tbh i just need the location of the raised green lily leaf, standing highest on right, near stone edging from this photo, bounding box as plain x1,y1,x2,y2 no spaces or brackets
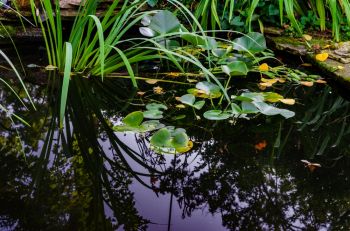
233,32,266,54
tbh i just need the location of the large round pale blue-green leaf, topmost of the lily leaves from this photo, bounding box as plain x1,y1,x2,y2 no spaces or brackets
149,10,181,35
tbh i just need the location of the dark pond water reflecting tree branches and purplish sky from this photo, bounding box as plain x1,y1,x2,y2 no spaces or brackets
0,46,350,231
